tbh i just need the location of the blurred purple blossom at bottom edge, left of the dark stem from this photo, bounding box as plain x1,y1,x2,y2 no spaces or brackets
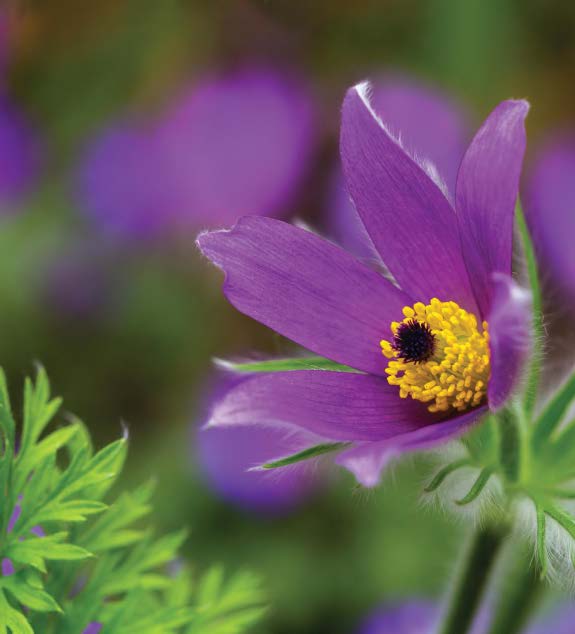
358,600,439,634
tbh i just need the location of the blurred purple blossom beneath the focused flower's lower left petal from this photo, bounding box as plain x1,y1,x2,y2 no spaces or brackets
193,377,314,514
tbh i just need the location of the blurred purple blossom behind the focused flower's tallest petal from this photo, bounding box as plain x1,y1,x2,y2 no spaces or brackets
325,76,469,259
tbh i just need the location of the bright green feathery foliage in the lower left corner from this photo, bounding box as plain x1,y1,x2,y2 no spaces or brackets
0,369,263,634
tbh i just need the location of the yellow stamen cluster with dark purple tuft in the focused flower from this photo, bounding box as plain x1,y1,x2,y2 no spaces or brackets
381,298,489,412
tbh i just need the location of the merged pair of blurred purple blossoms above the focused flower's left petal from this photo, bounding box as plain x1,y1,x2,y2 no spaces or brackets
78,68,314,239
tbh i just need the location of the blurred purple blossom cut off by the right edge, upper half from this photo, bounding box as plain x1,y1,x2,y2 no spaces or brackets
525,133,575,304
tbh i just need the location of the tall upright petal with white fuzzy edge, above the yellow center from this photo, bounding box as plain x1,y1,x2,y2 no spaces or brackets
341,84,476,311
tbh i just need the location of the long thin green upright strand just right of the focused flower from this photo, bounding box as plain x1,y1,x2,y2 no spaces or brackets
515,201,543,419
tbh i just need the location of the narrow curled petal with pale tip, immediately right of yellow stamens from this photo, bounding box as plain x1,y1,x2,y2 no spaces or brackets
487,273,532,411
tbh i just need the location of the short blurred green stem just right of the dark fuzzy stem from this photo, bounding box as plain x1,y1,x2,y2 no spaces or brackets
489,549,543,634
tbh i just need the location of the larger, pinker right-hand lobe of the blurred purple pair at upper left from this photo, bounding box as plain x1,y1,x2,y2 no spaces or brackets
160,68,315,227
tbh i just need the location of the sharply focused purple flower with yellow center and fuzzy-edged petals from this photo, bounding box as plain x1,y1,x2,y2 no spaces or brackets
198,84,530,486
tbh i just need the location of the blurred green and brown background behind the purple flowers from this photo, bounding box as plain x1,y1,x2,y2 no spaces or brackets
0,0,575,634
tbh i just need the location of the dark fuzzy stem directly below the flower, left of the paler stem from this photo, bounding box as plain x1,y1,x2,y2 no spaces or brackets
439,526,506,634
